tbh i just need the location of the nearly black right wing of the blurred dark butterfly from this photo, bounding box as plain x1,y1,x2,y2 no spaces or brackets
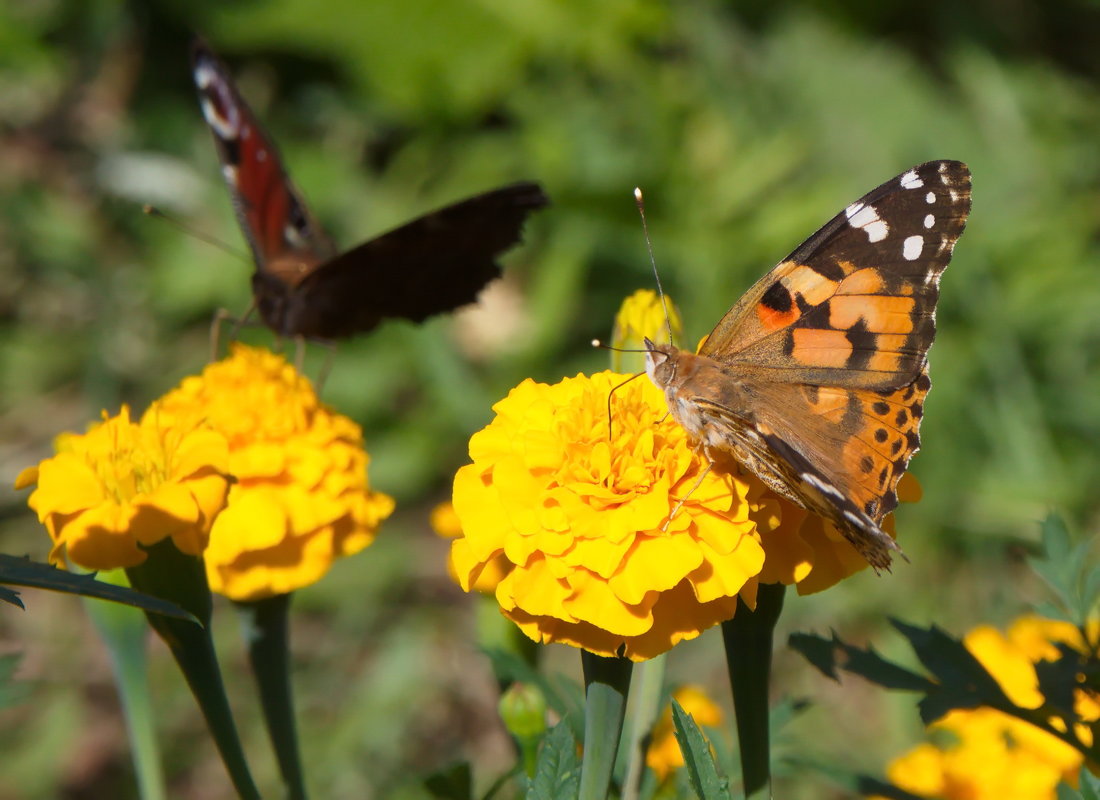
287,182,549,339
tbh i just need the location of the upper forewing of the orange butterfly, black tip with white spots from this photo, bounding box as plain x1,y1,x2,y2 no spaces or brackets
700,161,970,390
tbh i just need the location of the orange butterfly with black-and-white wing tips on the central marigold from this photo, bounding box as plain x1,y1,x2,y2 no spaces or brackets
647,161,970,569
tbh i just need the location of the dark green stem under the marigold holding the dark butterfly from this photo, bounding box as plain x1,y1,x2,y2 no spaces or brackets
237,594,306,800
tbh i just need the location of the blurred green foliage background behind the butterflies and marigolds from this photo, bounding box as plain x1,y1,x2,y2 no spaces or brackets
0,0,1100,800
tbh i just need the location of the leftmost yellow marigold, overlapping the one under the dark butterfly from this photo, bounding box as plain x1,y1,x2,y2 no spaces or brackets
15,406,229,570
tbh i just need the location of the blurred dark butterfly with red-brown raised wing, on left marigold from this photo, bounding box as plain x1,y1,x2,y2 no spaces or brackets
191,40,549,340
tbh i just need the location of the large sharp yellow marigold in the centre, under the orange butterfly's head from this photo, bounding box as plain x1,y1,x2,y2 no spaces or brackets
452,372,779,660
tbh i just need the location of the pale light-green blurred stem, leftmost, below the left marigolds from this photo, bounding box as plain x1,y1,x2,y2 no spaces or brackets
85,570,167,800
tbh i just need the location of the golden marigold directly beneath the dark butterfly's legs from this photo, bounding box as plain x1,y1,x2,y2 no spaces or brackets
145,344,394,601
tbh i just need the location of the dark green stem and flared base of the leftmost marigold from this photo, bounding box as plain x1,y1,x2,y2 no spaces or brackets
127,539,260,800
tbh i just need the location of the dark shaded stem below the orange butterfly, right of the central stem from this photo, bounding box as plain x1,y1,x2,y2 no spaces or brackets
722,583,785,798
